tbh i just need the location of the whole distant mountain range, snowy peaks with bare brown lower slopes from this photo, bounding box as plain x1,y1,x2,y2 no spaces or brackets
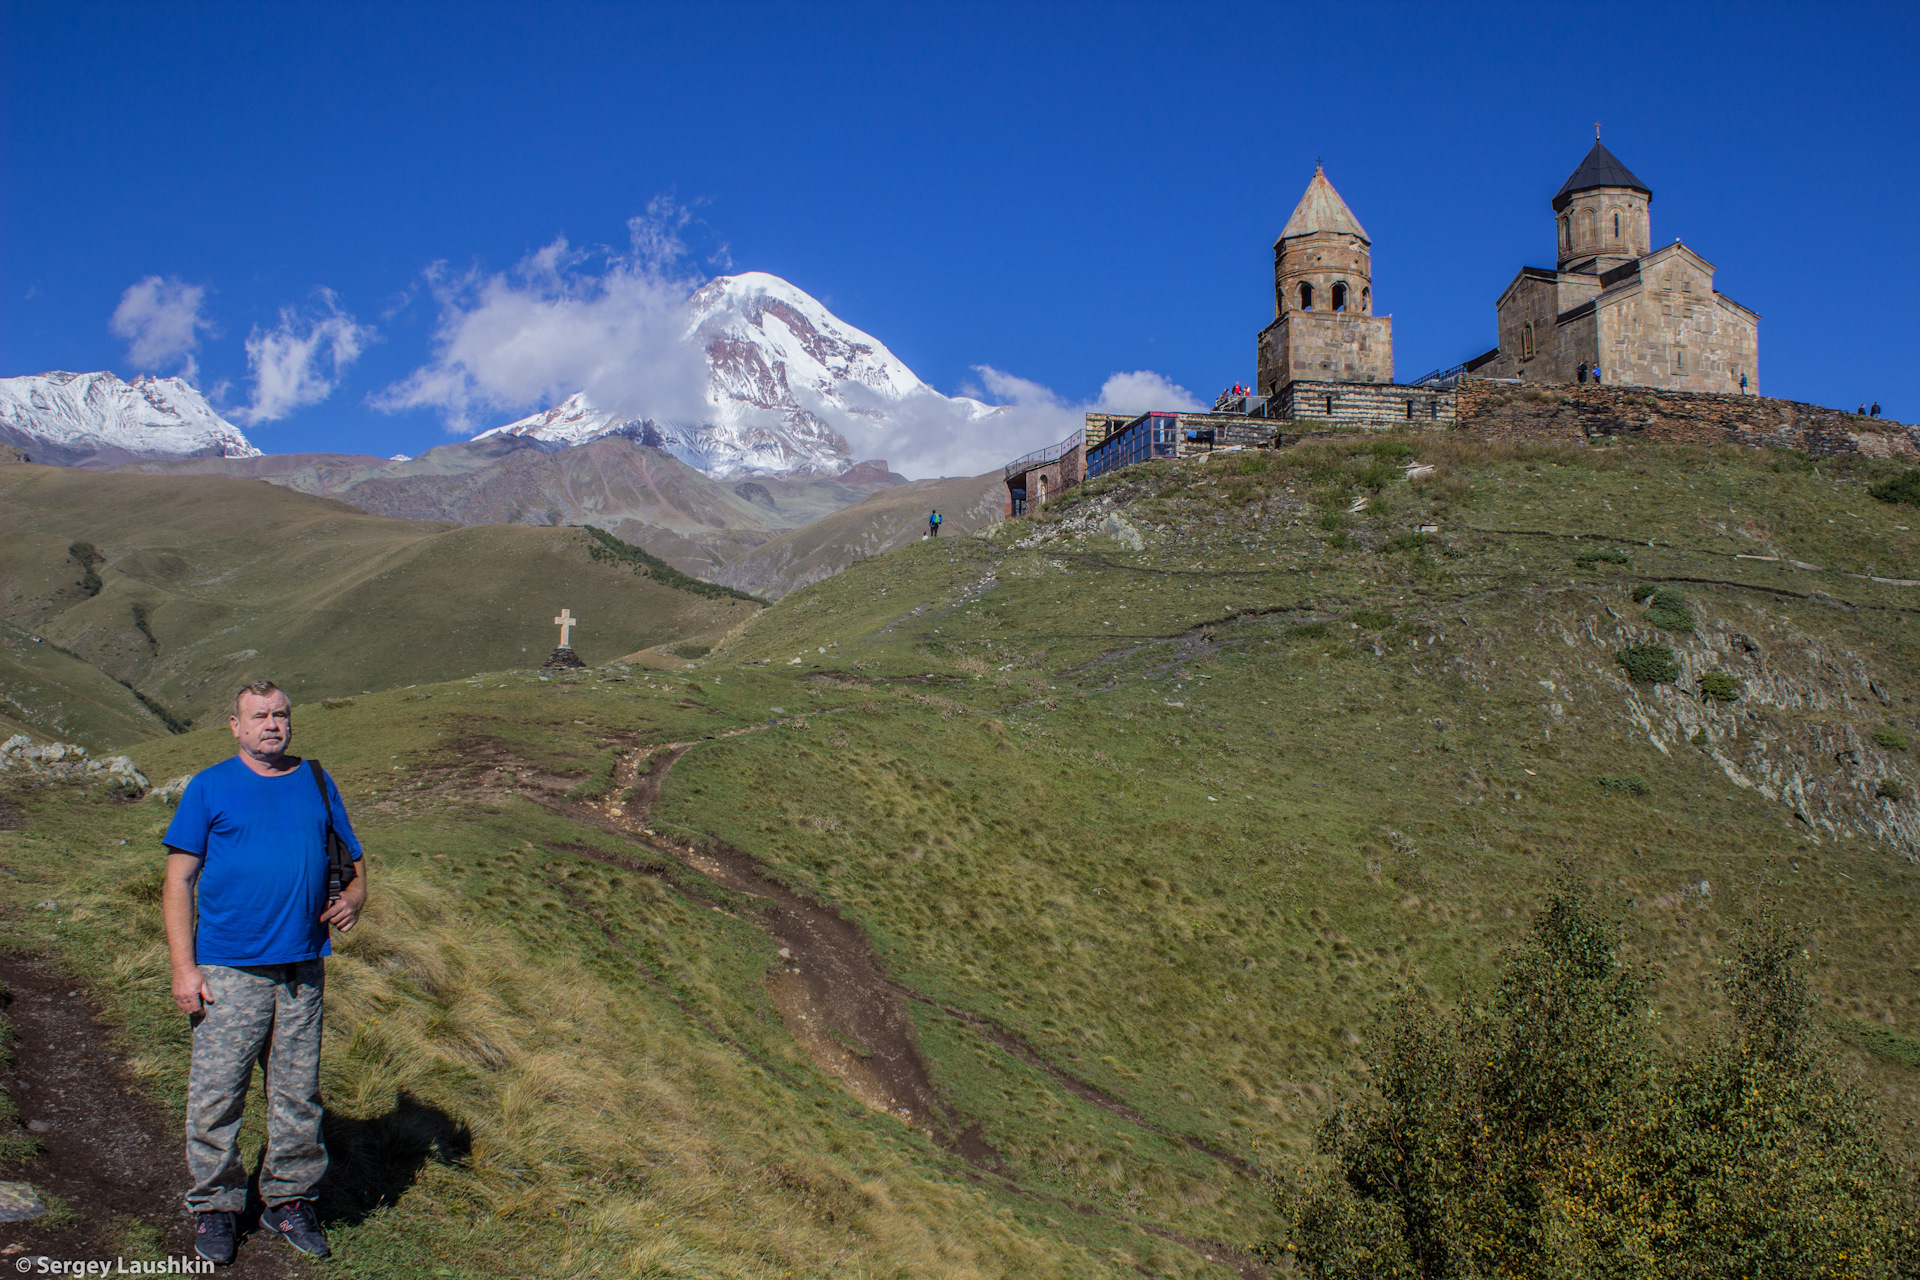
0,273,1002,595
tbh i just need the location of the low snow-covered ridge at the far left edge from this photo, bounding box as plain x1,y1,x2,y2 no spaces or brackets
0,370,259,462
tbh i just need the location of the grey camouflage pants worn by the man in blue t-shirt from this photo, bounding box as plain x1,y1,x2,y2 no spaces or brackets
186,960,326,1213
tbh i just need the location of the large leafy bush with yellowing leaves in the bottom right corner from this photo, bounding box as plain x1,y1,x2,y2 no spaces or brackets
1263,883,1920,1280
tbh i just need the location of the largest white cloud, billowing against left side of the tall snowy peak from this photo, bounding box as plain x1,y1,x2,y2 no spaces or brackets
374,198,724,434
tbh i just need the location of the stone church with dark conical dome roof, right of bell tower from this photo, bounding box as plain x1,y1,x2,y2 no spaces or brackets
1466,138,1761,395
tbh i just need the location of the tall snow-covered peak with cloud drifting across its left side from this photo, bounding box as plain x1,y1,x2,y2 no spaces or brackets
474,271,1000,478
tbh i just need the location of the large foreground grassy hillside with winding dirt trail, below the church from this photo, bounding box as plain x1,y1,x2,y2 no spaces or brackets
0,436,1920,1276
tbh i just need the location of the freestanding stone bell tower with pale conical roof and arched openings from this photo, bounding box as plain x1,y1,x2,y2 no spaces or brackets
1258,165,1394,395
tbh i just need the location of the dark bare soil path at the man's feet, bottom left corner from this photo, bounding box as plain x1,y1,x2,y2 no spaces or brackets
0,954,301,1278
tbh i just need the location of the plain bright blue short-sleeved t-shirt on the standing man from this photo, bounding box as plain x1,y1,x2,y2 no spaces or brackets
161,756,361,965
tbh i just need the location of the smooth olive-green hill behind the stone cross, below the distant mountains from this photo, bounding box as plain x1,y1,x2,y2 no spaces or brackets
0,466,755,743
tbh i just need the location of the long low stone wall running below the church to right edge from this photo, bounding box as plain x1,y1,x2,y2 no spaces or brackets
1453,378,1920,461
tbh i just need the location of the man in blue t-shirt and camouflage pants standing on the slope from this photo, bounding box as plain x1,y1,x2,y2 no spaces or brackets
161,679,367,1267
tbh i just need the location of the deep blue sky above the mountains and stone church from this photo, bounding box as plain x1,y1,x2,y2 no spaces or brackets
0,2,1920,455
